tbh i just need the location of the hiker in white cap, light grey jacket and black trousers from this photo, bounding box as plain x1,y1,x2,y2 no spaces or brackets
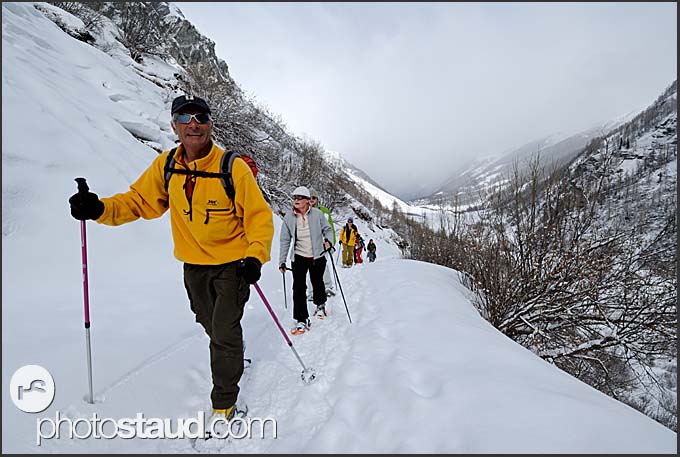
279,186,333,335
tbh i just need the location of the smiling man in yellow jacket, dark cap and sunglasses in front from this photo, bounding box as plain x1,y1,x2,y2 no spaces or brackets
69,96,274,419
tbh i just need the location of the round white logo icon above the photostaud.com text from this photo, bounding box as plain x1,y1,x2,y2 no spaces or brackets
9,365,54,413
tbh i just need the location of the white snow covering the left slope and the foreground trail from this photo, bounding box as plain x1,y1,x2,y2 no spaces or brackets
2,3,676,453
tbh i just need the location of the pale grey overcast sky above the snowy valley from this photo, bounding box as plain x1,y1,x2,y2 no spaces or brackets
176,2,677,198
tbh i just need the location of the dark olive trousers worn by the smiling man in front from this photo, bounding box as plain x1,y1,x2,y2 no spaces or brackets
184,262,250,409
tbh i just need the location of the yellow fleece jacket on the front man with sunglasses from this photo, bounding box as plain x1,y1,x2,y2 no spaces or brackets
97,143,274,265
